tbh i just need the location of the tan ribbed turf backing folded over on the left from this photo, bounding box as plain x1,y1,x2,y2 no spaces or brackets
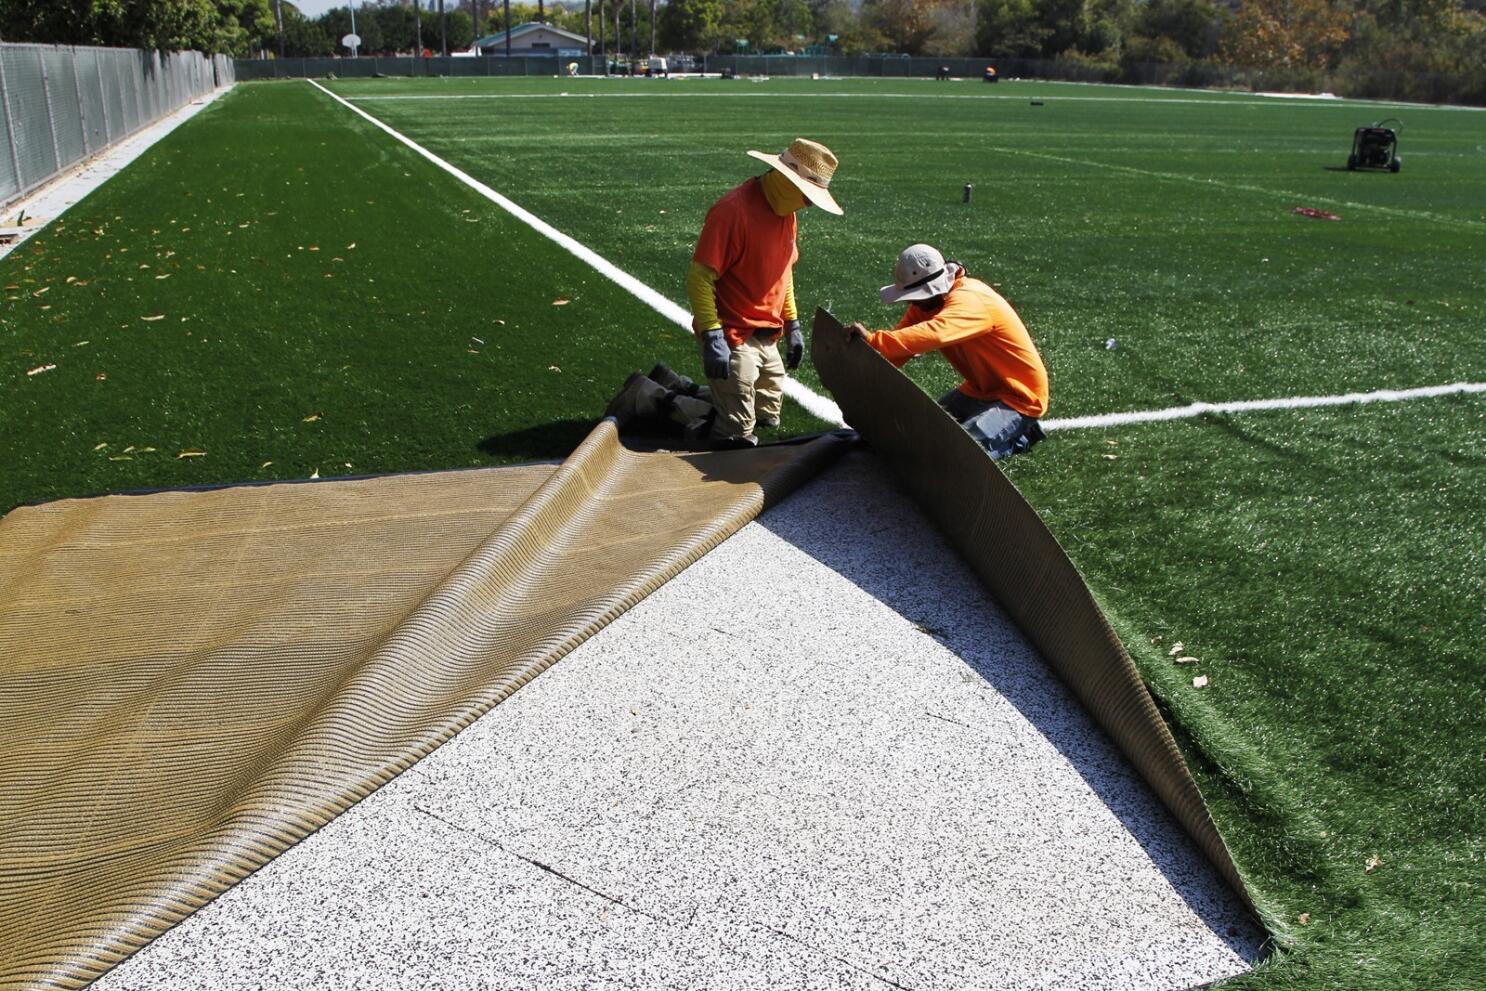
0,420,847,988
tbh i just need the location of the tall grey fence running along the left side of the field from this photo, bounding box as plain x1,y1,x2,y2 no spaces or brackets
0,45,236,212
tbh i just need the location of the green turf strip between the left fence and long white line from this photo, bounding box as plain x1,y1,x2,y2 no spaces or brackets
0,83,823,511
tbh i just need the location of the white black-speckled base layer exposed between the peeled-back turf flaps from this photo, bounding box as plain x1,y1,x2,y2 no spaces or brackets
95,455,1263,991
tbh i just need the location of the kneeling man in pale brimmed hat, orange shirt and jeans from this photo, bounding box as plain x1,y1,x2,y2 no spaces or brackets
851,244,1048,461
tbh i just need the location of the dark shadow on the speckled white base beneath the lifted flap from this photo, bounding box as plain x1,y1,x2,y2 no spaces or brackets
758,459,1266,963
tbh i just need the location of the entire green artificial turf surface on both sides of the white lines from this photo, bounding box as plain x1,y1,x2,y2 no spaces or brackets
0,79,1486,990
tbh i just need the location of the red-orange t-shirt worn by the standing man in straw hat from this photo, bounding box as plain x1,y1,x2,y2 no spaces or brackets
691,177,799,348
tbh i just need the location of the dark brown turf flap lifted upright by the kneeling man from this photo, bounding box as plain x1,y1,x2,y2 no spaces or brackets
810,311,1254,911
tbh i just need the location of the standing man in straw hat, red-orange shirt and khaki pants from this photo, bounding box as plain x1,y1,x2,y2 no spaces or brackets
687,138,841,447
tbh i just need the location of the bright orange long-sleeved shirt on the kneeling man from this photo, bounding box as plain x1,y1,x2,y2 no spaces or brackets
868,269,1048,417
